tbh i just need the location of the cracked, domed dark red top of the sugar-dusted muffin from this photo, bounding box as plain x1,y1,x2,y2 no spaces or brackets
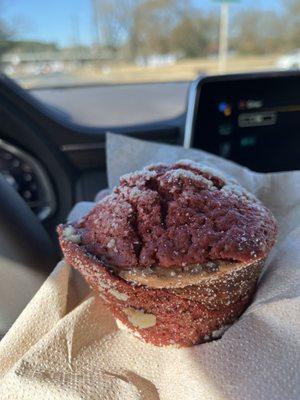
74,160,277,269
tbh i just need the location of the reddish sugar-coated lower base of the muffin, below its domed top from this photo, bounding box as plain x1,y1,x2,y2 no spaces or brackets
58,226,264,347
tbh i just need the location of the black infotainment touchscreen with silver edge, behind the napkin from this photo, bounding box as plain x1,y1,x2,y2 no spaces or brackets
185,72,300,171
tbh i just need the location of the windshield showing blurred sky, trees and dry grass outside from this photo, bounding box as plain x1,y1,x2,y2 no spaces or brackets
0,0,300,88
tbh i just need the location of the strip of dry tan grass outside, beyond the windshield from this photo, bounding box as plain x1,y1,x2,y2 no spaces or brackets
12,55,279,88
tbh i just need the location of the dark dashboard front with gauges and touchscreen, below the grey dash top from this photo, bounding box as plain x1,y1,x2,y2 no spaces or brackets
0,71,300,237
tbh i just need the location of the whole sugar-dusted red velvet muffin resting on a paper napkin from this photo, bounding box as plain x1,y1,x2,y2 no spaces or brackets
58,161,277,346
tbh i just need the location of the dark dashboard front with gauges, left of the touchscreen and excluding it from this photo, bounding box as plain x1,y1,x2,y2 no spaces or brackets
0,75,185,237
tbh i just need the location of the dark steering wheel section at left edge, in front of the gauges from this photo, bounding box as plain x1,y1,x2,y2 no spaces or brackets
0,175,59,336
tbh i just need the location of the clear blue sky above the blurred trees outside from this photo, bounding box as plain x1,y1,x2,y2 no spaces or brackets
0,0,281,46
